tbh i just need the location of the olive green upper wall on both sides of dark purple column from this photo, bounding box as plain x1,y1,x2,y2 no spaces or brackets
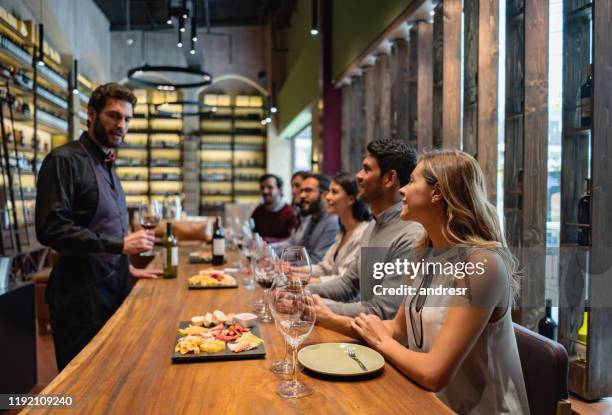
278,0,413,132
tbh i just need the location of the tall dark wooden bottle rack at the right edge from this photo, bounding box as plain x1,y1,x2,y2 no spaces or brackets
559,0,612,400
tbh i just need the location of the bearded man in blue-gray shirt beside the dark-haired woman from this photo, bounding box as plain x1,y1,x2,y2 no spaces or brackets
273,174,340,264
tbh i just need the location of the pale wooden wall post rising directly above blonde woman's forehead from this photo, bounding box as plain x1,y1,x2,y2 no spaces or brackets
442,0,463,149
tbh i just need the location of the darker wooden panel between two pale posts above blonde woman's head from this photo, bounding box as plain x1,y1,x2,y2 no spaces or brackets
463,0,480,157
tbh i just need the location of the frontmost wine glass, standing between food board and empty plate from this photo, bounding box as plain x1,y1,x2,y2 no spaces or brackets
271,278,316,399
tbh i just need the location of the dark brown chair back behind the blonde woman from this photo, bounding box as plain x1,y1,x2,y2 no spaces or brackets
514,323,572,415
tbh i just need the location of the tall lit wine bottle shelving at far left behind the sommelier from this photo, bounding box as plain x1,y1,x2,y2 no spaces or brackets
0,10,70,264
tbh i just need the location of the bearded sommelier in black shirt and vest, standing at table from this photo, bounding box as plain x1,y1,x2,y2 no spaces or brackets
36,83,156,371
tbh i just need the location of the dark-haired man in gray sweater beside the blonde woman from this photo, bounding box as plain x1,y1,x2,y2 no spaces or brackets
309,140,424,332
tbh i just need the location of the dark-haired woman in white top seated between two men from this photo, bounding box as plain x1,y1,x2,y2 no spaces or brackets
312,173,372,281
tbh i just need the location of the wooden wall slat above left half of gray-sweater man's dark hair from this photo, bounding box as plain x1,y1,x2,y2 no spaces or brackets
374,53,391,139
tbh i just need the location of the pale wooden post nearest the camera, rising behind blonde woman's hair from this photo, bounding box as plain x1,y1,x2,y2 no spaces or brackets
478,0,498,203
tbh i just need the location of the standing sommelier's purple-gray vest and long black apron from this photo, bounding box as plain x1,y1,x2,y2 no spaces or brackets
46,143,133,371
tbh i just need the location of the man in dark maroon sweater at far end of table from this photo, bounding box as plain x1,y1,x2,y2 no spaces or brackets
251,174,297,242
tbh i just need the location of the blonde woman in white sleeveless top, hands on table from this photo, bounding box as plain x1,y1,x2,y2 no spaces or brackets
351,150,529,414
